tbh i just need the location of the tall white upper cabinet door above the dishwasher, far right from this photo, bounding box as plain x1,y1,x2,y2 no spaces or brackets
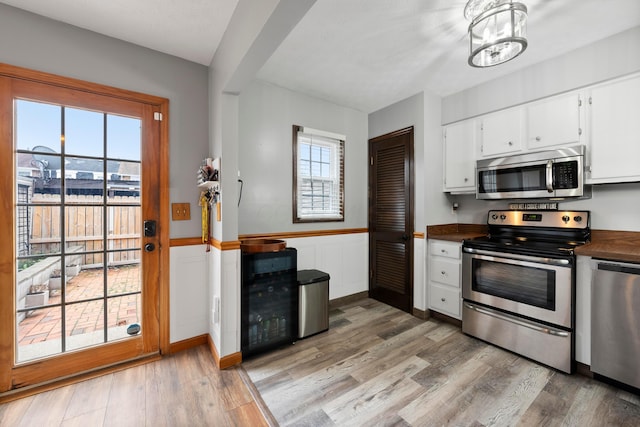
587,75,640,183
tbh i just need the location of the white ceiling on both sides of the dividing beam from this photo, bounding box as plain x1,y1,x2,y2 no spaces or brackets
0,0,640,112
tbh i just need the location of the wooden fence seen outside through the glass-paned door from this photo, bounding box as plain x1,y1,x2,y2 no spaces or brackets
29,194,142,266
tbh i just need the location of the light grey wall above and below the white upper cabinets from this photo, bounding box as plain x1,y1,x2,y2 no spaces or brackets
442,27,640,231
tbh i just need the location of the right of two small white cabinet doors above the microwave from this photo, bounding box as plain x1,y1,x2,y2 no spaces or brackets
526,93,582,149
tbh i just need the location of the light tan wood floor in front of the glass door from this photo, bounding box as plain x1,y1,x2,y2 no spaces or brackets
0,345,269,427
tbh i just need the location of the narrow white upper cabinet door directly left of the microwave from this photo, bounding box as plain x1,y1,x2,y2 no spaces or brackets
444,120,476,192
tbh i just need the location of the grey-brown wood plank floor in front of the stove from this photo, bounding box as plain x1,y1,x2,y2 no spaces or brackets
243,299,640,427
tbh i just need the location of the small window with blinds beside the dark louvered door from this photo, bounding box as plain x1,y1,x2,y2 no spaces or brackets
293,125,345,222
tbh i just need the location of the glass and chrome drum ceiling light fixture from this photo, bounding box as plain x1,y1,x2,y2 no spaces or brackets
464,0,527,68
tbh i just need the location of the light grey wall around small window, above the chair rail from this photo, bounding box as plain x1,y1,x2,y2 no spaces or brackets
238,81,367,234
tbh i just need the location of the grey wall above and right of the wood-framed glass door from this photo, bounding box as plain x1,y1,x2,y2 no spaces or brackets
0,4,208,242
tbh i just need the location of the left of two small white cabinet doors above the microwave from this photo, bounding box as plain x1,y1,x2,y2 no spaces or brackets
481,108,522,157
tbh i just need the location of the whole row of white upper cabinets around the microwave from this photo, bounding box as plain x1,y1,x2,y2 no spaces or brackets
443,73,640,187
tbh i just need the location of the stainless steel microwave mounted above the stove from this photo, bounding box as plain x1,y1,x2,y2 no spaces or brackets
476,145,585,199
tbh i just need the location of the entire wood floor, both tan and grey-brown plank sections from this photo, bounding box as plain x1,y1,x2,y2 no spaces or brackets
0,299,640,427
